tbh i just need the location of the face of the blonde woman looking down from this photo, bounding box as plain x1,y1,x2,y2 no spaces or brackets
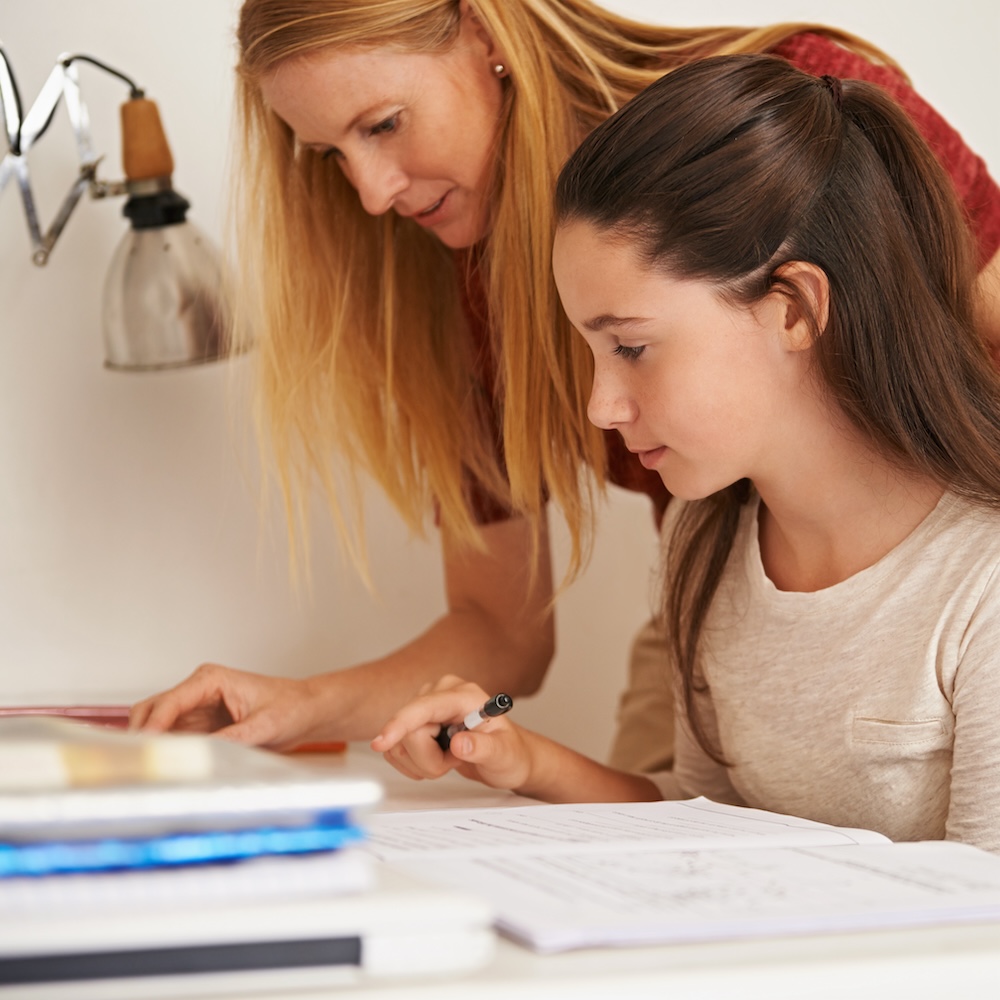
261,11,503,248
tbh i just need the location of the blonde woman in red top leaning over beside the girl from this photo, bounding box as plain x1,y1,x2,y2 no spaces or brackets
132,0,1000,765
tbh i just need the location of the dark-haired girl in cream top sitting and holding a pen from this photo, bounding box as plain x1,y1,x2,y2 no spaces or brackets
372,56,1000,850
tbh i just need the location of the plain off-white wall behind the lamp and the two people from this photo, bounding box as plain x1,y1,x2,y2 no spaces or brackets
0,0,1000,754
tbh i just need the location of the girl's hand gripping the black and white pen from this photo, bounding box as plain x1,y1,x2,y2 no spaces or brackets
371,676,531,789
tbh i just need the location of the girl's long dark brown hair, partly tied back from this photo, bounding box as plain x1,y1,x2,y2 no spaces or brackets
557,55,1000,760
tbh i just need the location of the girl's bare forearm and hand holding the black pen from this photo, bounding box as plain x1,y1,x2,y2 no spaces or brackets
372,677,662,802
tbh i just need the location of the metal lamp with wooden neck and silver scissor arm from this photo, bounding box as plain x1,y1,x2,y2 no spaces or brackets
0,43,227,371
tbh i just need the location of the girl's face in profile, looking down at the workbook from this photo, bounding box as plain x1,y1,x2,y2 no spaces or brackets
553,222,804,499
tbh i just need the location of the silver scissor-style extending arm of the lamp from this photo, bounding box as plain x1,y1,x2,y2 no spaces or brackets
0,43,142,266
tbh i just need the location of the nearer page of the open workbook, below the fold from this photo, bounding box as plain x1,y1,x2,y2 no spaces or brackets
390,841,1000,951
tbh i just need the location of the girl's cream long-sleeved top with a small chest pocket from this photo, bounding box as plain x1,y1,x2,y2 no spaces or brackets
648,493,1000,851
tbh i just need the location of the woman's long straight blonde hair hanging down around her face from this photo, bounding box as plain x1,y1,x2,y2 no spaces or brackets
236,0,886,577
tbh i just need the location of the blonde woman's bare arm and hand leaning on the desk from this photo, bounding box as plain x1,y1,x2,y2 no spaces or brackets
130,519,555,749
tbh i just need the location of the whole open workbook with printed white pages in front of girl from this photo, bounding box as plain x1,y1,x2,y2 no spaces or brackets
372,800,1000,951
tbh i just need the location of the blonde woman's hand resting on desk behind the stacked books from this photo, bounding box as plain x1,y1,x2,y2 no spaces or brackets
129,663,315,750
